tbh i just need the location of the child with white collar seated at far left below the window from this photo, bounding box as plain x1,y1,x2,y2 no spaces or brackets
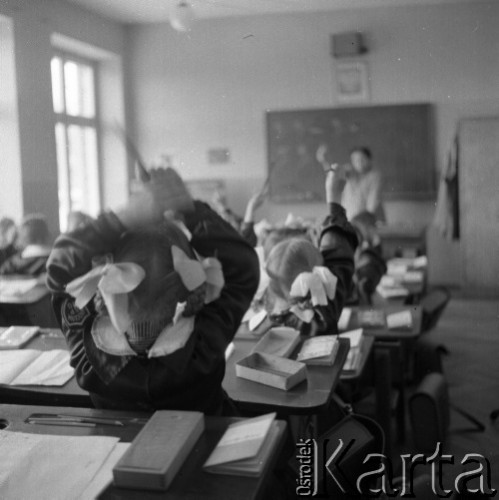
0,214,52,277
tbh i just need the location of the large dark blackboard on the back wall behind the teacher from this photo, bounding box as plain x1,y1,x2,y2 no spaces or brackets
266,104,436,203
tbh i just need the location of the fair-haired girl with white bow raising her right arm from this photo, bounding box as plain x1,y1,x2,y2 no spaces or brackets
262,168,357,333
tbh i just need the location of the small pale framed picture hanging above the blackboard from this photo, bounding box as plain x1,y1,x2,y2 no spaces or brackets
335,61,369,103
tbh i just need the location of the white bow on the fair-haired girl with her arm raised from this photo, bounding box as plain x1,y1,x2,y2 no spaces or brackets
289,266,338,323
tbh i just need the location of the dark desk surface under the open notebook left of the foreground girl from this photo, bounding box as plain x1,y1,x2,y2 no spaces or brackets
0,329,93,408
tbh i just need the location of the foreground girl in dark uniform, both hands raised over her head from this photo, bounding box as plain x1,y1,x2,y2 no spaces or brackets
47,169,259,415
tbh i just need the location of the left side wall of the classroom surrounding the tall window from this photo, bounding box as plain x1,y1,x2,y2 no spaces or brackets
0,0,128,233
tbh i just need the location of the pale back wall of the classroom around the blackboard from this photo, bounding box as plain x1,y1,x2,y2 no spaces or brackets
128,1,499,283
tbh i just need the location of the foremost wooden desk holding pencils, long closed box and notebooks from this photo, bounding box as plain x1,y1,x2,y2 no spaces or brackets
0,404,286,500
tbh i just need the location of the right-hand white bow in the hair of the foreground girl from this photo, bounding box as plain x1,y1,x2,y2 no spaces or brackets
172,245,225,304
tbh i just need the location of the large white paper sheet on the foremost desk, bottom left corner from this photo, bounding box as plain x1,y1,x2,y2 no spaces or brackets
0,431,119,500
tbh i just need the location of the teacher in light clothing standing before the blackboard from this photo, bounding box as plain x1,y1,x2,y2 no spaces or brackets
316,145,385,222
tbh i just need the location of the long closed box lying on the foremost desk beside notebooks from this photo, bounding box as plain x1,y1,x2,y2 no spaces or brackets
113,410,204,491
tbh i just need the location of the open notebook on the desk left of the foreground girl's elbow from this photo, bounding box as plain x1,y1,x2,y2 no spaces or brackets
0,349,74,386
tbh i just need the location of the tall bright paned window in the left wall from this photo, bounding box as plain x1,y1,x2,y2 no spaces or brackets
51,53,100,231
